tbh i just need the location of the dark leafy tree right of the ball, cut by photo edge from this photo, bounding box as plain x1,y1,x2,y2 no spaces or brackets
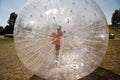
111,9,120,27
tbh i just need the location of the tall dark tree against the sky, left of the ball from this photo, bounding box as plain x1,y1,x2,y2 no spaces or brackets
4,12,17,34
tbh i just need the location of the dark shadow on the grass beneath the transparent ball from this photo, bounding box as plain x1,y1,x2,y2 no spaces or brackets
30,67,120,80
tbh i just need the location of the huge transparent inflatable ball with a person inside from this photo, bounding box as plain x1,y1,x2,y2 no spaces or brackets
14,0,108,80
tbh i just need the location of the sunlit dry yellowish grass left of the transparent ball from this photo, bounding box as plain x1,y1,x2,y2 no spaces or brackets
0,39,32,80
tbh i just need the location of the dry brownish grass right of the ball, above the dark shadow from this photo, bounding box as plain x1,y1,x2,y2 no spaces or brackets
100,40,120,75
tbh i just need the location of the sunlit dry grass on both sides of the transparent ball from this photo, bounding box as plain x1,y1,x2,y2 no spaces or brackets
0,38,120,80
